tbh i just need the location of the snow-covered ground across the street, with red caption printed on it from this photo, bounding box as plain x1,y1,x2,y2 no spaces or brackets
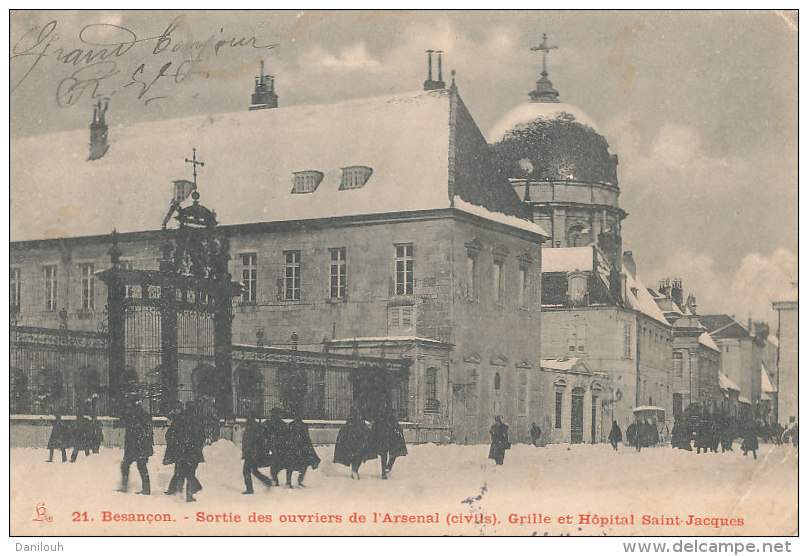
10,440,797,535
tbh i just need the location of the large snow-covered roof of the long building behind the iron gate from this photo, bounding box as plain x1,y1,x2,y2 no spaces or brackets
10,90,520,241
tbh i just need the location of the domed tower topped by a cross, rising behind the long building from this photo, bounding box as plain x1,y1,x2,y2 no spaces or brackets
488,34,626,269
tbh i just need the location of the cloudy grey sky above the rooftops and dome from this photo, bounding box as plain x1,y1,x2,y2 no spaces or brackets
10,11,798,321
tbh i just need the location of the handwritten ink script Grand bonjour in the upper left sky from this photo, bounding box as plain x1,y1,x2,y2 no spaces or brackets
9,16,278,108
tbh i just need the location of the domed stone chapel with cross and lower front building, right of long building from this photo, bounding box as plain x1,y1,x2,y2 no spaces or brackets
488,43,672,434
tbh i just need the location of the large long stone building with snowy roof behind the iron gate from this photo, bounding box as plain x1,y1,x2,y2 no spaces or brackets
10,59,547,442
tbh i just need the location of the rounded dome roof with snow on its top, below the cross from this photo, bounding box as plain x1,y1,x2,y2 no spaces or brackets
488,101,617,185
